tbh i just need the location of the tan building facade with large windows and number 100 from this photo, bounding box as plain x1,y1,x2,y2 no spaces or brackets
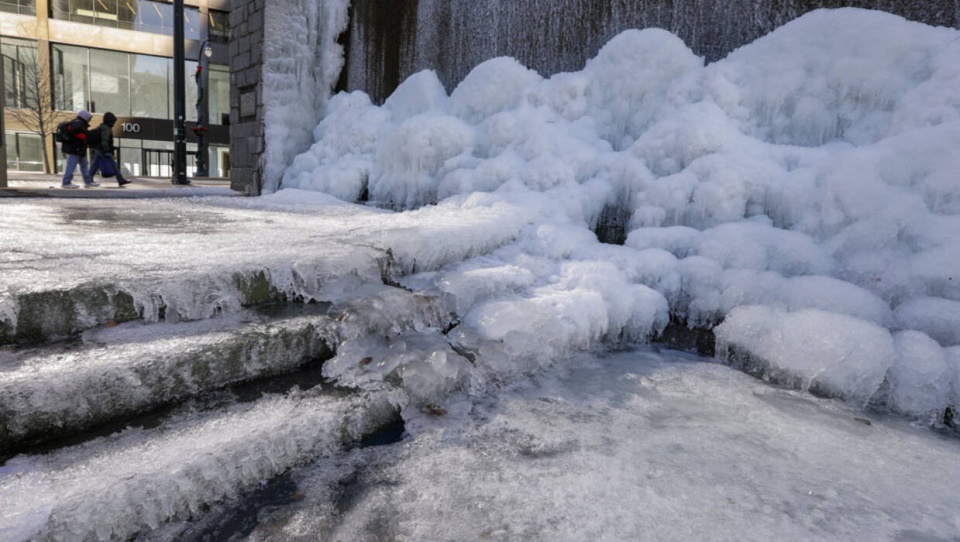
0,0,231,177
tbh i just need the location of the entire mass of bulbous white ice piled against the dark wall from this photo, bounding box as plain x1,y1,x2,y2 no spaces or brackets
281,9,960,422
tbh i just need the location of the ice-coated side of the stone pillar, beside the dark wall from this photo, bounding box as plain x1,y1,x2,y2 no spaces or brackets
262,0,349,193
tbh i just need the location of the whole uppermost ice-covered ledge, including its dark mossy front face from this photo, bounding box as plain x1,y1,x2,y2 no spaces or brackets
0,188,522,344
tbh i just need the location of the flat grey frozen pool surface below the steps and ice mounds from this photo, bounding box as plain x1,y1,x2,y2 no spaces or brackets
182,350,960,542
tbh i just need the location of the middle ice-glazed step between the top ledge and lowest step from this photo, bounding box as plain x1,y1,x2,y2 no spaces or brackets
0,286,450,455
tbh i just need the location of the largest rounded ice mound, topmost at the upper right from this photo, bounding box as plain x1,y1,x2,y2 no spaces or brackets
707,8,960,146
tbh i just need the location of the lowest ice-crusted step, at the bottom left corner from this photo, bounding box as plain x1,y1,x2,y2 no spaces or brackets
0,388,398,541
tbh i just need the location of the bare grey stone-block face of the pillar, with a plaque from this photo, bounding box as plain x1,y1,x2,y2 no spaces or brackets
230,0,266,196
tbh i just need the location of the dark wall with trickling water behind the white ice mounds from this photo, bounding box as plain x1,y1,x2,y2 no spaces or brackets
344,0,960,102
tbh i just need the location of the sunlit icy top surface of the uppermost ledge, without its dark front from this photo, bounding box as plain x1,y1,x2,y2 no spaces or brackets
0,190,524,298
